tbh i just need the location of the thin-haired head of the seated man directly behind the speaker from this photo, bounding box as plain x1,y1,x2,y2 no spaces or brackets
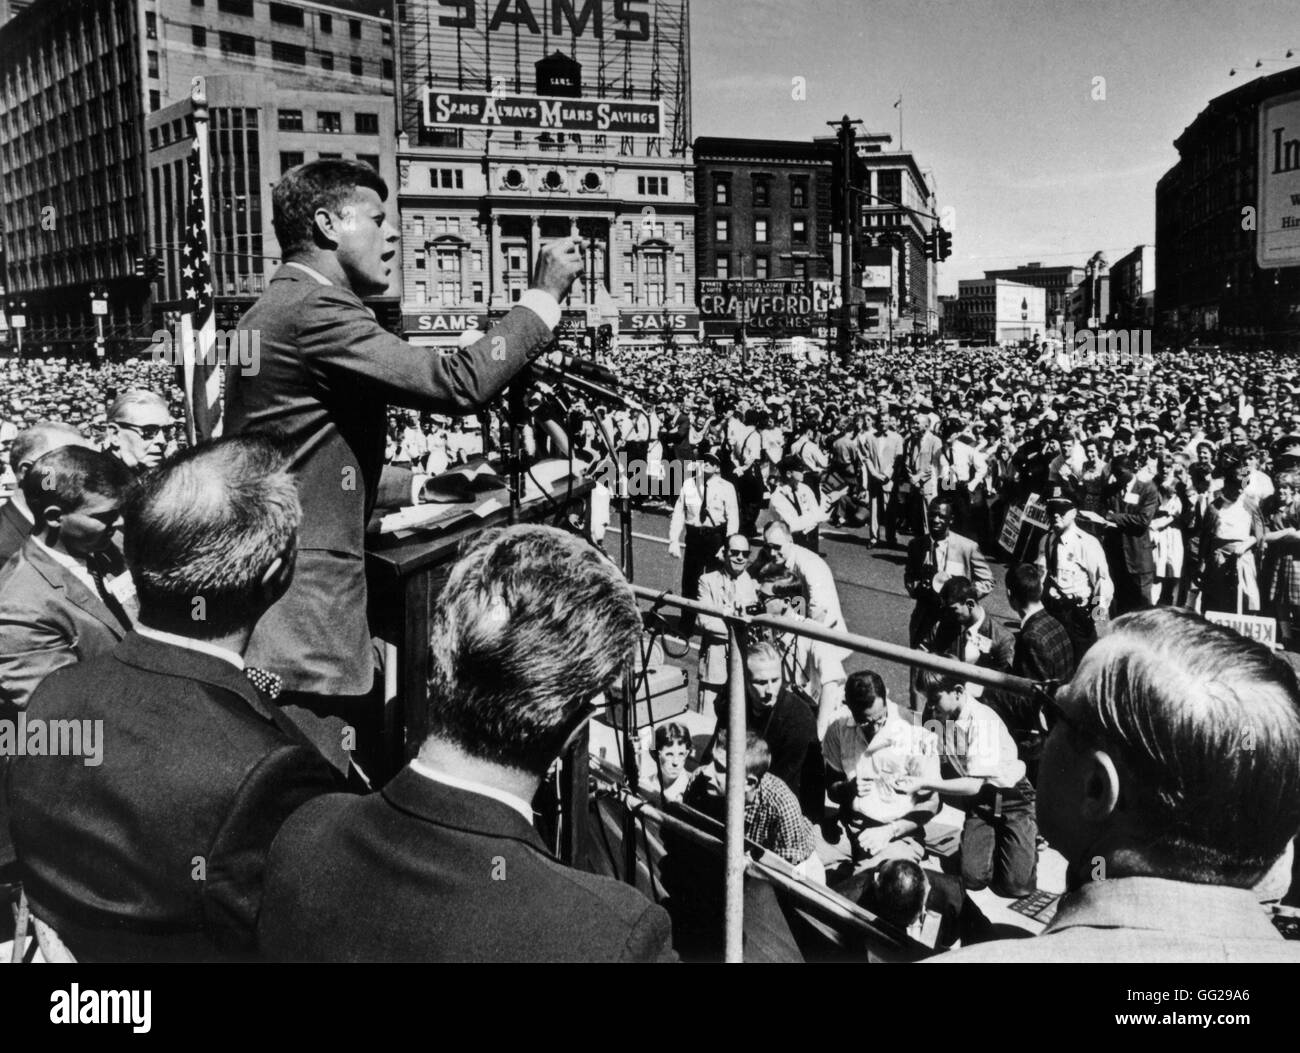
124,436,302,638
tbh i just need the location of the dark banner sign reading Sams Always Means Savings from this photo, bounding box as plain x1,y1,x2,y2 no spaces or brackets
424,88,663,137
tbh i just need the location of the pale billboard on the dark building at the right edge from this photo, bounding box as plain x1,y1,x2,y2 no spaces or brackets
1255,91,1300,267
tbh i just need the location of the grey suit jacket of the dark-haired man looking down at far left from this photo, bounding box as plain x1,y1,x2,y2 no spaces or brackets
0,537,134,712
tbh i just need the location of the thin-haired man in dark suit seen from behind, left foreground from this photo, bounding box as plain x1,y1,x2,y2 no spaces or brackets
9,438,342,962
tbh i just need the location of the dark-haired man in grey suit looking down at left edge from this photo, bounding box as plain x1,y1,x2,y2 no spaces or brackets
0,446,135,715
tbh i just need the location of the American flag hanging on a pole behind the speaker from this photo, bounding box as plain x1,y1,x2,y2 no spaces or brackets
181,132,221,443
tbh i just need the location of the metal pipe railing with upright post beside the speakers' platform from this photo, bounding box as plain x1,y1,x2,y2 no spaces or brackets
608,585,1047,962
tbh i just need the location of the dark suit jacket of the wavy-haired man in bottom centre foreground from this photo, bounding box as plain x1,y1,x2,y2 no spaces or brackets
257,768,675,962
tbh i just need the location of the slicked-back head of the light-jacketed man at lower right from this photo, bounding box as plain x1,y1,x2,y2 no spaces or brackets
1039,607,1300,888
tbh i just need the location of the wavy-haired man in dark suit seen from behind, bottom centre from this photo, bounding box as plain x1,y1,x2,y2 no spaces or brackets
259,527,675,962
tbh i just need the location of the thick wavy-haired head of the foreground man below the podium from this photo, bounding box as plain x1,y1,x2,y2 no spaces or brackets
429,527,641,774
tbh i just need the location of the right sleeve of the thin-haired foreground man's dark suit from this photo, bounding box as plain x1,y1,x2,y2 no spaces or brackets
203,745,343,950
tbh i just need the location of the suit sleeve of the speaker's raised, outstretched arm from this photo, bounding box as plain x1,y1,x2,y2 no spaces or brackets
298,286,553,415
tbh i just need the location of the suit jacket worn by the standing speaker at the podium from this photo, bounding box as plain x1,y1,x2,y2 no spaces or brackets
225,264,551,696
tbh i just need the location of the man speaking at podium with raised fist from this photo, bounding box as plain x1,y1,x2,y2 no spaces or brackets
225,160,582,720
